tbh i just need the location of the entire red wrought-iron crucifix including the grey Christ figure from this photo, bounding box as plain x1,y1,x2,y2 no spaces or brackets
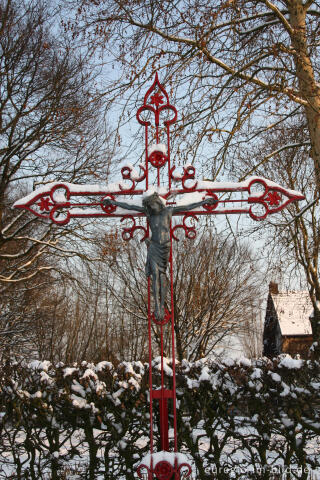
14,74,304,480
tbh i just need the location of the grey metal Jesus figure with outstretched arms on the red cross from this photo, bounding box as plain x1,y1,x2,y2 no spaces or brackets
103,192,217,320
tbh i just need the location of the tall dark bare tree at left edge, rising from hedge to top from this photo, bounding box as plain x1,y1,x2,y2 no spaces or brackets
0,0,119,359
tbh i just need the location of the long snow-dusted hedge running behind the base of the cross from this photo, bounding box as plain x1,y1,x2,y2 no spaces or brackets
0,356,320,480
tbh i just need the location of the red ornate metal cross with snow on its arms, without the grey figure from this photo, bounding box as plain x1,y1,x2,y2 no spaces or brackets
14,74,304,480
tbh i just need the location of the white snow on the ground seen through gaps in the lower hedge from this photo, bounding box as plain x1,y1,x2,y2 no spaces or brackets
0,416,320,480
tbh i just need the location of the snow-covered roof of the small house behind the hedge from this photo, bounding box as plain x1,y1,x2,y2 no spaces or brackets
271,291,313,335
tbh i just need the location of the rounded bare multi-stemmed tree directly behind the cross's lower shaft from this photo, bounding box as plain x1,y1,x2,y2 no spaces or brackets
94,228,259,360
